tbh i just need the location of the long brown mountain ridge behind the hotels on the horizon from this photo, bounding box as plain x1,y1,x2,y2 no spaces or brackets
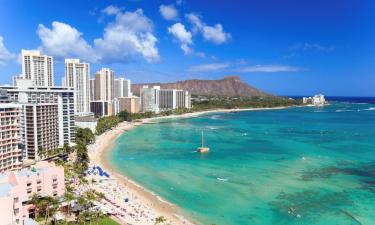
132,76,268,97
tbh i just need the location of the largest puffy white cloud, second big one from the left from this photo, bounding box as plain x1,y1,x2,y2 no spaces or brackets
94,9,159,63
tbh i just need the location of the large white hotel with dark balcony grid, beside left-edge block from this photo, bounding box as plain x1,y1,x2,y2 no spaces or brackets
0,83,75,160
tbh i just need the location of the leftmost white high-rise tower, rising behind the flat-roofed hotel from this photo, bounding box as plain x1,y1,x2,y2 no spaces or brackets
18,50,54,87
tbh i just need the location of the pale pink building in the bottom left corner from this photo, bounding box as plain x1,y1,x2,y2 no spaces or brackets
0,161,65,225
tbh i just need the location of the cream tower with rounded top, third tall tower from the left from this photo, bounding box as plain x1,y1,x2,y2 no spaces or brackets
94,68,115,101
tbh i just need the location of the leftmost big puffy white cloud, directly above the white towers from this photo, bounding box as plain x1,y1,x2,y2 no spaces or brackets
37,21,97,62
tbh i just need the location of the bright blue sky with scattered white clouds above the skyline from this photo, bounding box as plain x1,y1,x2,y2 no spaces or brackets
0,0,375,96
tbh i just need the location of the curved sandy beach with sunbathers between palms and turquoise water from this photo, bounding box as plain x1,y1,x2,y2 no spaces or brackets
88,107,286,225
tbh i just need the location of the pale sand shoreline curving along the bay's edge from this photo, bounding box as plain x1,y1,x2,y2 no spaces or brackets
88,107,289,225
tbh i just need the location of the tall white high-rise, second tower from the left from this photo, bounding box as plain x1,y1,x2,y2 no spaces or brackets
63,59,90,114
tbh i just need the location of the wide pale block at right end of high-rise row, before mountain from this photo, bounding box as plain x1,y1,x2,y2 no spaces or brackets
159,89,191,110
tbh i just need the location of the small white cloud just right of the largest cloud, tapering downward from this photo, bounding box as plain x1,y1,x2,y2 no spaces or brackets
168,23,193,55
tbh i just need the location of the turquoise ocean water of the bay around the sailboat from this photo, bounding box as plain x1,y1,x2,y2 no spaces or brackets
108,102,375,225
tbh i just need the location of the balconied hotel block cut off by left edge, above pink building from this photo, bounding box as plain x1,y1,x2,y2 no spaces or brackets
0,89,22,173
